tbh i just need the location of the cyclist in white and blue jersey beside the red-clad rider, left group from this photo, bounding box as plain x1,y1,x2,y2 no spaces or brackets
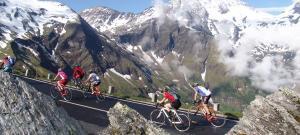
85,70,101,95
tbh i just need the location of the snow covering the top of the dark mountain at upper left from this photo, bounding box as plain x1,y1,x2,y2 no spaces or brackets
0,0,78,38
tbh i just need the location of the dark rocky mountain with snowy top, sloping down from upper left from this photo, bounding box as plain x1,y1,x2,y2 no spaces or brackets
0,0,152,93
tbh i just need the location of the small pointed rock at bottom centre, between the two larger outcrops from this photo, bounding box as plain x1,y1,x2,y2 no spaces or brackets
106,103,168,135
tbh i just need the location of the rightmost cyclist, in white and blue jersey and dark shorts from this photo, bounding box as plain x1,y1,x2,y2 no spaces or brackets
192,83,211,116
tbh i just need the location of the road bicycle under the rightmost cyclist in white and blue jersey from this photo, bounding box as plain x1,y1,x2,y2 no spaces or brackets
188,100,226,127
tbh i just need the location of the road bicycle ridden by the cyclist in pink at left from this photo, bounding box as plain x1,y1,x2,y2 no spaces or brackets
50,84,72,101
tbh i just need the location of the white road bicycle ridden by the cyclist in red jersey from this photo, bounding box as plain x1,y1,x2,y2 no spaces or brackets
150,104,191,132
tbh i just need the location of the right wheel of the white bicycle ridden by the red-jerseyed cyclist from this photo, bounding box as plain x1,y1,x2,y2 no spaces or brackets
172,114,191,132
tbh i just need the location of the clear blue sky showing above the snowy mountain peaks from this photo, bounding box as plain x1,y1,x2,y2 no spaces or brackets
57,0,292,14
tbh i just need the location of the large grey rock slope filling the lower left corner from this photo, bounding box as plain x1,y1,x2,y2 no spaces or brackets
0,72,85,135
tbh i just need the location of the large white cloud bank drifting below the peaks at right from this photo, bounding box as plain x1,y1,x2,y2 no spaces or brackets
219,26,300,91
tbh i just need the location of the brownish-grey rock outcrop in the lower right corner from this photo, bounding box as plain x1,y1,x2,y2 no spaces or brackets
228,90,300,135
